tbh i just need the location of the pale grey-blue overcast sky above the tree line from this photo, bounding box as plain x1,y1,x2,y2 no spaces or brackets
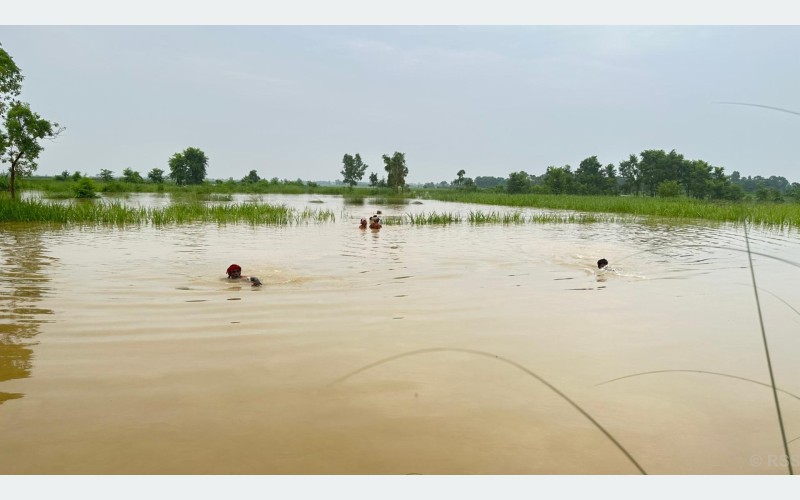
0,22,800,182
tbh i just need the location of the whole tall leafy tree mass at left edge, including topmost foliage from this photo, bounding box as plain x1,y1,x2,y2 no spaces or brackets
0,46,63,200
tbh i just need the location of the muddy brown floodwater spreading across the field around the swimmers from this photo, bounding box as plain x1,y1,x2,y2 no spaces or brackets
0,195,800,474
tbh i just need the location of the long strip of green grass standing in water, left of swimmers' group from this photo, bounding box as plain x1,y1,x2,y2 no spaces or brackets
0,198,335,225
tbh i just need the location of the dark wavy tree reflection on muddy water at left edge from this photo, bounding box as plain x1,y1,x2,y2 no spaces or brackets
0,225,53,405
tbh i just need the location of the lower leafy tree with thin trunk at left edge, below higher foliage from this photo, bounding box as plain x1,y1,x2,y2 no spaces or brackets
0,102,64,200
